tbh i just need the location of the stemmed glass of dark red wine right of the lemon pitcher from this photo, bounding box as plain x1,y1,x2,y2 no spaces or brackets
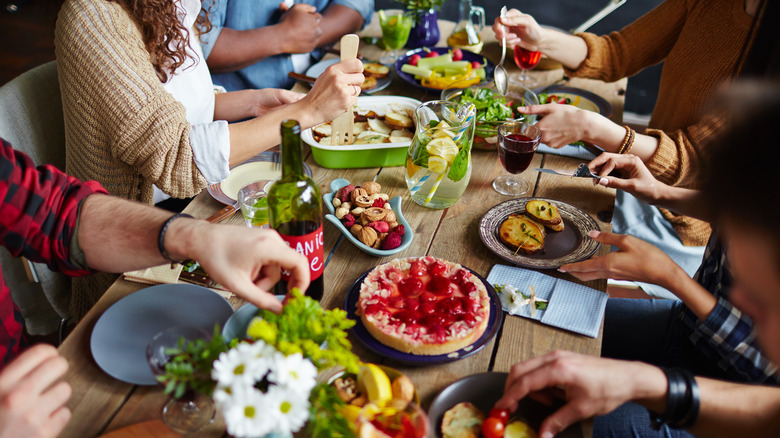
493,121,542,196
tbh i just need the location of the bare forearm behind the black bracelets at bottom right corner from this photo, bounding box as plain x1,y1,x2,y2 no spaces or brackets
690,378,780,437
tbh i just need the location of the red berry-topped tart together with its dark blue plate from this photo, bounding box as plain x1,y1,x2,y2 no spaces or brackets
345,256,503,365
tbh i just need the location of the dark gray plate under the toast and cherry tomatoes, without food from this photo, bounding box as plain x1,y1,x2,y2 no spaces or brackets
428,373,582,438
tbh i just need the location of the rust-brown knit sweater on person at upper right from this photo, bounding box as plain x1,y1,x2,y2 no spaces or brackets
568,0,752,246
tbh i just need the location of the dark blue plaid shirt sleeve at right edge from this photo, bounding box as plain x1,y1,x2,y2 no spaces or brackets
680,233,780,384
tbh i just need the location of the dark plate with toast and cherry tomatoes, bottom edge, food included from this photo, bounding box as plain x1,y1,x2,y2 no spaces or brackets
428,373,583,438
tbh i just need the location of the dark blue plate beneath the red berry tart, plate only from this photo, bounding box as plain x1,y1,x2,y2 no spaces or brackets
344,268,503,365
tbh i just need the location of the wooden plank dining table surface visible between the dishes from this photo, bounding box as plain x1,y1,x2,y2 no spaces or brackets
60,20,626,438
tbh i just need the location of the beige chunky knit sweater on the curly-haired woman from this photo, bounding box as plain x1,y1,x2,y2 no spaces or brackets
55,0,206,319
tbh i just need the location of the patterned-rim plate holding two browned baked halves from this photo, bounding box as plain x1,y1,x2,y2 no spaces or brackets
479,198,600,269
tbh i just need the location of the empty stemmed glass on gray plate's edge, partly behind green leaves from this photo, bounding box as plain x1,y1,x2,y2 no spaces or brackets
146,327,217,434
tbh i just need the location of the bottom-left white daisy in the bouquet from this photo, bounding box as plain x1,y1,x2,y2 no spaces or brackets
223,386,274,437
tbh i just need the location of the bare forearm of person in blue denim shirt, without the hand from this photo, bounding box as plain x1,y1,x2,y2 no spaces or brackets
206,26,285,73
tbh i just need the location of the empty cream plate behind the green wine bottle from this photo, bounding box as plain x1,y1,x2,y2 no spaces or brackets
206,151,311,205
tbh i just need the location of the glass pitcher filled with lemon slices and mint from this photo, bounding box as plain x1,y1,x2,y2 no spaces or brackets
405,100,477,209
